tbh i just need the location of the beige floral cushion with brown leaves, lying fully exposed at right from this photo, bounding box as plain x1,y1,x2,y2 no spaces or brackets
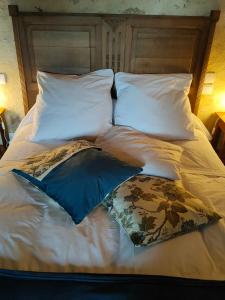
104,175,221,246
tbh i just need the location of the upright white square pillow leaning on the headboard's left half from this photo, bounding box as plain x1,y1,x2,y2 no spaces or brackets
29,69,114,142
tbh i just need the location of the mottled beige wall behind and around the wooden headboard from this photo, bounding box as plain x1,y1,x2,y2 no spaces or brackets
0,0,225,132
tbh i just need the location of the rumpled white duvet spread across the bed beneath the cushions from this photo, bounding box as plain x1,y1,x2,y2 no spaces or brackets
0,123,225,280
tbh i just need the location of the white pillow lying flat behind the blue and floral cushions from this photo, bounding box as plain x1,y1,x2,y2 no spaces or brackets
95,126,182,180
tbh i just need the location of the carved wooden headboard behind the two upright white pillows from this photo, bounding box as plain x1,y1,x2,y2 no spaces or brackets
9,5,220,113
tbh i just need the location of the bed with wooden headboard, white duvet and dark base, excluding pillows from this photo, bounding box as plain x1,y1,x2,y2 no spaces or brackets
0,6,225,299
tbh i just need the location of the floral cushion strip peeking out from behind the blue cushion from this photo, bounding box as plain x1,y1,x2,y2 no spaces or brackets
16,140,99,180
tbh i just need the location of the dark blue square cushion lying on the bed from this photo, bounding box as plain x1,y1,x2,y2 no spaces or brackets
13,148,142,224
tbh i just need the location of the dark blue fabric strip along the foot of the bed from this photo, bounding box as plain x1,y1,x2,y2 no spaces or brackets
0,269,225,300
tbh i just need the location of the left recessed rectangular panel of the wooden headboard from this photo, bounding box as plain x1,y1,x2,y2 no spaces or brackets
33,31,91,74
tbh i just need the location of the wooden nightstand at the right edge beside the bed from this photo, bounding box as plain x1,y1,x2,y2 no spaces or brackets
212,112,225,164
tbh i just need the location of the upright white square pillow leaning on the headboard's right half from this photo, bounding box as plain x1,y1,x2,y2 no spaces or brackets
115,72,194,140
